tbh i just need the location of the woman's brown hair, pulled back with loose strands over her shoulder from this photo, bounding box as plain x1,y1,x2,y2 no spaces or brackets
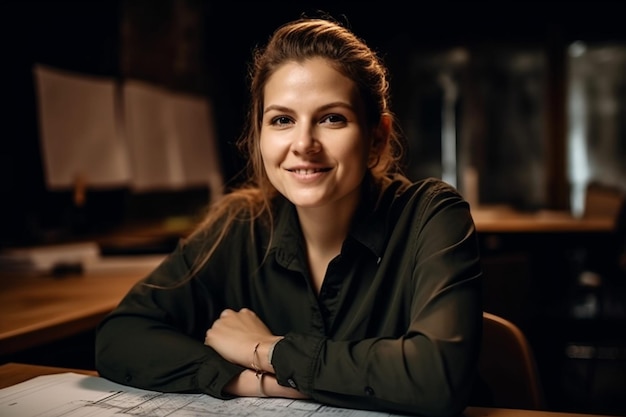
182,17,402,273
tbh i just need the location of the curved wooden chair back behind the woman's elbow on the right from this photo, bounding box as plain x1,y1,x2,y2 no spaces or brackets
478,312,544,410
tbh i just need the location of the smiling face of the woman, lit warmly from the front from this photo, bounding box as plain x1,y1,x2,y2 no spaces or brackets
260,58,372,210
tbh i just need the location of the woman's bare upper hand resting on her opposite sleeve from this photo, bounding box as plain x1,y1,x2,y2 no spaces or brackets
204,308,277,371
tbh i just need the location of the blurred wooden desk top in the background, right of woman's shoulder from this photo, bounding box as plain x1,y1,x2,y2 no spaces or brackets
472,207,615,233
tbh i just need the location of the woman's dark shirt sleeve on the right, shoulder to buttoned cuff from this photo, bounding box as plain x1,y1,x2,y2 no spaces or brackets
273,181,482,416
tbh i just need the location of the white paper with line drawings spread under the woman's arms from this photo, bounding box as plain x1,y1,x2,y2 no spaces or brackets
0,372,394,417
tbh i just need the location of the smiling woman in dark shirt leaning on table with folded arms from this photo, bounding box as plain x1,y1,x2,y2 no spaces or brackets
96,18,482,416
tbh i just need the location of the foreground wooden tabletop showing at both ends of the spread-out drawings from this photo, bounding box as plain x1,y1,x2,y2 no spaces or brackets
0,363,606,417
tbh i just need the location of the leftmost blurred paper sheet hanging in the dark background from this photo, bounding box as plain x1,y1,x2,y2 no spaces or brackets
34,65,131,189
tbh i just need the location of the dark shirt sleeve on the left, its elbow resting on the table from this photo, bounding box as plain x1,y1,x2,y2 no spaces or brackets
96,237,243,398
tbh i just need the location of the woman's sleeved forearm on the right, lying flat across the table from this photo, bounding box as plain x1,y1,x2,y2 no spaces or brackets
273,302,477,415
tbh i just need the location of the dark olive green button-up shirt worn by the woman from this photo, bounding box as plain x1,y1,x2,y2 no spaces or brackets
96,179,482,416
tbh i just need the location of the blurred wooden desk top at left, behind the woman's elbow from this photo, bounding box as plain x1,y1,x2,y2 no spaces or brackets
0,262,161,356
